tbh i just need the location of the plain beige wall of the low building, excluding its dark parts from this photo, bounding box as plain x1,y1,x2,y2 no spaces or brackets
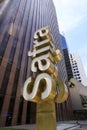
69,78,87,110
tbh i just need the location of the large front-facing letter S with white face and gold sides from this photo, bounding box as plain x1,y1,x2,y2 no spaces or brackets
23,73,56,102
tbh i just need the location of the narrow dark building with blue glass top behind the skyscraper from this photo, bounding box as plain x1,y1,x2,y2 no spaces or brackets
60,34,73,80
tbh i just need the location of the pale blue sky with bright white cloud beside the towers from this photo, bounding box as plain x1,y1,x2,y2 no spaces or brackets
53,0,87,76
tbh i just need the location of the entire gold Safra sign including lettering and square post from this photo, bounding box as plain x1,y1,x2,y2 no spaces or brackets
23,27,68,130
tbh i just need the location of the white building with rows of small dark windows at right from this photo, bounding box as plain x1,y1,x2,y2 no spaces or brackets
70,53,87,86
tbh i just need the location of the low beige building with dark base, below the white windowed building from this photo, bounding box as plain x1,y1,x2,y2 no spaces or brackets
69,78,87,120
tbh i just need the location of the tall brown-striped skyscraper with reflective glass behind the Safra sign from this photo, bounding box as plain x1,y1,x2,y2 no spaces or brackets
0,0,72,126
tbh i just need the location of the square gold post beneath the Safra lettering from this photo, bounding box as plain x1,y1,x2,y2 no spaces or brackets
36,101,57,130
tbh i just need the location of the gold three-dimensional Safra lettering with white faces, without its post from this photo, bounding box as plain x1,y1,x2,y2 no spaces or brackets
23,27,68,103
